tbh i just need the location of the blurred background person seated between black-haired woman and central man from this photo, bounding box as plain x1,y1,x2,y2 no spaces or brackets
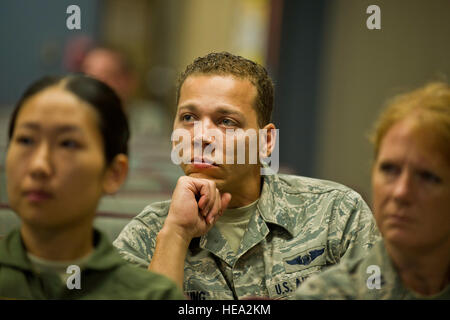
81,46,182,195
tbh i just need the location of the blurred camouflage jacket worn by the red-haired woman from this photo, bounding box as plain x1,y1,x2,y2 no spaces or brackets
295,241,450,300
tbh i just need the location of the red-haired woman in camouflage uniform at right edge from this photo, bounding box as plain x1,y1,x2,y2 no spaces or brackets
296,83,450,299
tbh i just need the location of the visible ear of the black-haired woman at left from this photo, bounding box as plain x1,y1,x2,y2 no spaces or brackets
103,153,128,194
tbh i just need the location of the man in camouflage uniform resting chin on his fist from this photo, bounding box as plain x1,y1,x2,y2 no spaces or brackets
114,53,378,299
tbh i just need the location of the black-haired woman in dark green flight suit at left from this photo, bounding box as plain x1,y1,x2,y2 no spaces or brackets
0,75,184,299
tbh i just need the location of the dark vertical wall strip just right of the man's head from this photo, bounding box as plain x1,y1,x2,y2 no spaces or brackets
273,0,326,176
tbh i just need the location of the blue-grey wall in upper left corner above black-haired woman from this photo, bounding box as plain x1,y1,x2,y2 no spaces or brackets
0,0,101,107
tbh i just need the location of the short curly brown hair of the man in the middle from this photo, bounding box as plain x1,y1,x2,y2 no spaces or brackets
176,52,274,127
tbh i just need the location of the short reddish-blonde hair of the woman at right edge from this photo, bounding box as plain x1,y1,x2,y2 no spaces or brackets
370,82,450,159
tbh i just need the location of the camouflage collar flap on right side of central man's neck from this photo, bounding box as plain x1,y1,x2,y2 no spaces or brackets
257,174,294,237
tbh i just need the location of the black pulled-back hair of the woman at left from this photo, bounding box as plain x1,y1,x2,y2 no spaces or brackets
8,74,130,164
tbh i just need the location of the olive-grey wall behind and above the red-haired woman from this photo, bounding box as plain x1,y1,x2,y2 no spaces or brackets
315,0,450,202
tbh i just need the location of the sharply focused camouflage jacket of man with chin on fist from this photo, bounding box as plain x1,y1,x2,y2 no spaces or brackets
114,174,379,299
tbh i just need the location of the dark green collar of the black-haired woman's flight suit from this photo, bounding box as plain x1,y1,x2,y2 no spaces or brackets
0,229,124,271
